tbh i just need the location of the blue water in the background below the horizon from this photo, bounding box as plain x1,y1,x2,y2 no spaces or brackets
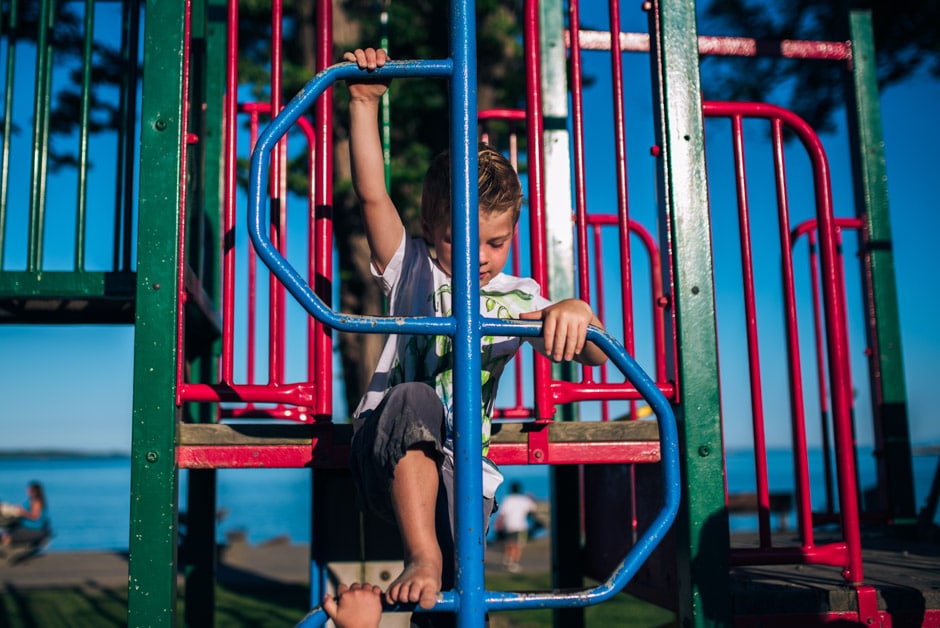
0,449,938,551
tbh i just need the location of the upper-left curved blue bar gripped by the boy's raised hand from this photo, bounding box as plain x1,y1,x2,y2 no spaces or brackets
248,60,456,336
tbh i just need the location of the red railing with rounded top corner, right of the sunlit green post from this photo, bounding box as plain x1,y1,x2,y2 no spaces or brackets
703,102,862,583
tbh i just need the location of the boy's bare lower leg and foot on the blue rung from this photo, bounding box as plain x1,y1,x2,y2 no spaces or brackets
385,448,443,608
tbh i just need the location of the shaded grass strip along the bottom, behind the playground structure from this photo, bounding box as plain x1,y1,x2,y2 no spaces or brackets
0,574,675,628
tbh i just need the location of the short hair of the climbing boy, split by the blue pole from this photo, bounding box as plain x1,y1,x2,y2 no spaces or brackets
421,143,522,230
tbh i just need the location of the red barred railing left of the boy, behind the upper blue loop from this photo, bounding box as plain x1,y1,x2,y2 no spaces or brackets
179,0,333,422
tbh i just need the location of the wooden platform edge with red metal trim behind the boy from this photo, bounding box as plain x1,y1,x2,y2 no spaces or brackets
177,420,659,469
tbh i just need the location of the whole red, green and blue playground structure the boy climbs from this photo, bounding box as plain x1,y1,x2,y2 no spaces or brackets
0,0,940,626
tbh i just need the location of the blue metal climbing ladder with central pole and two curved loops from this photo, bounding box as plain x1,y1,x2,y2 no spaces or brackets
248,55,680,626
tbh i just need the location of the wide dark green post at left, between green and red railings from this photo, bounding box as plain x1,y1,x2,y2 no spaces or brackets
128,0,186,627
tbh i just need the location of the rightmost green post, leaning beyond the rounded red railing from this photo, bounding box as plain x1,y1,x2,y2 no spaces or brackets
847,10,916,523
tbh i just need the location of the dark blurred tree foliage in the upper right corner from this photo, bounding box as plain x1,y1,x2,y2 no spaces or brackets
702,0,940,131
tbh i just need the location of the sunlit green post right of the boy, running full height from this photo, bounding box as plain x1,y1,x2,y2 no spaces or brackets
649,0,730,627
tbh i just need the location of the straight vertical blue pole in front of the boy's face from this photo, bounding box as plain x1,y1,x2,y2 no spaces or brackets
450,0,486,628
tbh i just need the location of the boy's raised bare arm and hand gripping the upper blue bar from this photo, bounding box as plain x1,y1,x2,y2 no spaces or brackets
344,48,405,272
